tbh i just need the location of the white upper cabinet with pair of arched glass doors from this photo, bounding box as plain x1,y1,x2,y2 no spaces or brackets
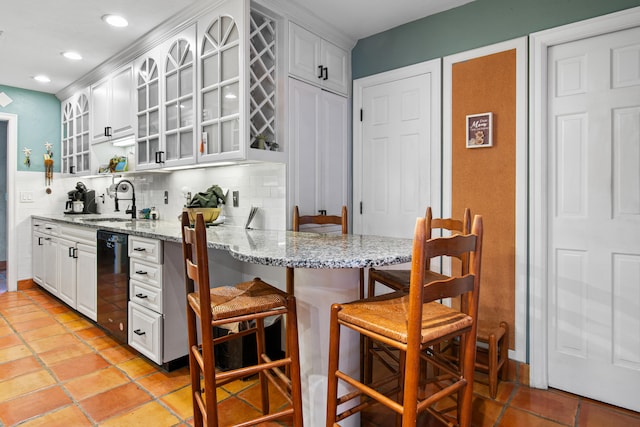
134,26,196,170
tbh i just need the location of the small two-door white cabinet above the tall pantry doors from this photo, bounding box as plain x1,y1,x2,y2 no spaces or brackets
289,22,350,95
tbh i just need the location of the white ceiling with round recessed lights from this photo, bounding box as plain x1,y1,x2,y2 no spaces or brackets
0,0,472,93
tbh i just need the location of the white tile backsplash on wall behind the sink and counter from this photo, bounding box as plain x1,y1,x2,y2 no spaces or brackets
15,163,287,279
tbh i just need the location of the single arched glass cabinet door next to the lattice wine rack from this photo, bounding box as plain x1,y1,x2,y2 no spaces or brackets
198,0,249,162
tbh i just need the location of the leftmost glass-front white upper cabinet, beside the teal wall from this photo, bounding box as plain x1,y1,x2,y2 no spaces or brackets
61,90,91,175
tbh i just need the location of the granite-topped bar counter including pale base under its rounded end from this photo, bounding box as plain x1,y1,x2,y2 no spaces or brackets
33,215,412,427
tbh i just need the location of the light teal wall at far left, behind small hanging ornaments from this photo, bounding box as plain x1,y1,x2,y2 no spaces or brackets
0,85,60,172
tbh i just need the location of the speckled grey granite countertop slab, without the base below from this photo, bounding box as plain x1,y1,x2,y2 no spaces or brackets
32,214,412,268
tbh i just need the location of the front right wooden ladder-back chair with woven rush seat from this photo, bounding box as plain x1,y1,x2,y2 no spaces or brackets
326,215,483,427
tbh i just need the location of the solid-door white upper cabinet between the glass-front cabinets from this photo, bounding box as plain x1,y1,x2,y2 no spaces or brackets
91,65,134,142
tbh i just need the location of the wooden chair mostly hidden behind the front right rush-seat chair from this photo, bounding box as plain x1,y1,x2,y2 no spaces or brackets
363,206,471,381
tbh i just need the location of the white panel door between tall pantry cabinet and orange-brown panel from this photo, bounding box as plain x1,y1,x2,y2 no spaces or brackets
354,68,441,238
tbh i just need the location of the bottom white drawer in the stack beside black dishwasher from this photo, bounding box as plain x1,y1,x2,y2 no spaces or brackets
128,301,162,364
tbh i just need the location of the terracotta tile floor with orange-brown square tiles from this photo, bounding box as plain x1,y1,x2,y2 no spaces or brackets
0,288,640,427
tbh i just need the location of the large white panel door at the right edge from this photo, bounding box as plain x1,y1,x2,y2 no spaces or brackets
548,28,640,411
